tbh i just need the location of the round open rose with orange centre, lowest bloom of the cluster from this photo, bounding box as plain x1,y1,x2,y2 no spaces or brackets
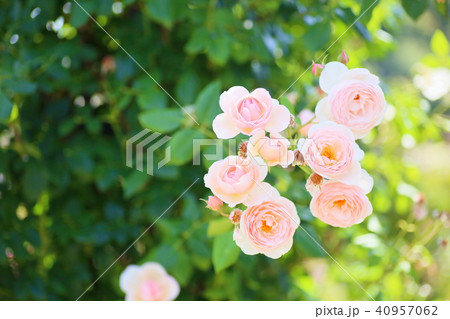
233,195,300,258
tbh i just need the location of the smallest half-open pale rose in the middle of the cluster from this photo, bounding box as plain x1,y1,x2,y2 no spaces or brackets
247,130,294,167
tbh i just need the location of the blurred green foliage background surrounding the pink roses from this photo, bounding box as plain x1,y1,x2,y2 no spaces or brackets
0,0,450,300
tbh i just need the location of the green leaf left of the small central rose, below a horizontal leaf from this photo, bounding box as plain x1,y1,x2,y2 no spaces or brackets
169,128,205,165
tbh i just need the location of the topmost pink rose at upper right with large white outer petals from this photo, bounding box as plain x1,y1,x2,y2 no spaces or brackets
316,62,387,138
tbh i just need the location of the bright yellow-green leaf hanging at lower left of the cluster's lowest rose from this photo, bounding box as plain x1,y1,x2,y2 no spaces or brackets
212,231,239,273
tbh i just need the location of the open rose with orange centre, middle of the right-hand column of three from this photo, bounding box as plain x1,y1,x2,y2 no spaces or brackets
297,121,364,185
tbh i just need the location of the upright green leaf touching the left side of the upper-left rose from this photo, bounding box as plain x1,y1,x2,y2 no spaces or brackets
195,81,221,127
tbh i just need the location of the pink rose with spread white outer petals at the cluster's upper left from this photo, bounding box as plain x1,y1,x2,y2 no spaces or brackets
213,86,290,139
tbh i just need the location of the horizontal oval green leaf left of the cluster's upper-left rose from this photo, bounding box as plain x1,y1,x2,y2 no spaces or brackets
139,108,183,133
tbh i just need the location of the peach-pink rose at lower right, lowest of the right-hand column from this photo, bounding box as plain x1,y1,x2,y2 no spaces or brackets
310,181,372,227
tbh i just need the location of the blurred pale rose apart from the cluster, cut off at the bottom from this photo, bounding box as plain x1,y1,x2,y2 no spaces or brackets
120,262,180,301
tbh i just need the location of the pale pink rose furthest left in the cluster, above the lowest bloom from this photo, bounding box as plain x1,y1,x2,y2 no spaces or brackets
204,156,274,207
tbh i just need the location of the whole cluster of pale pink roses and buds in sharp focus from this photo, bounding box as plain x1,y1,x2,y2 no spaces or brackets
204,62,386,258
